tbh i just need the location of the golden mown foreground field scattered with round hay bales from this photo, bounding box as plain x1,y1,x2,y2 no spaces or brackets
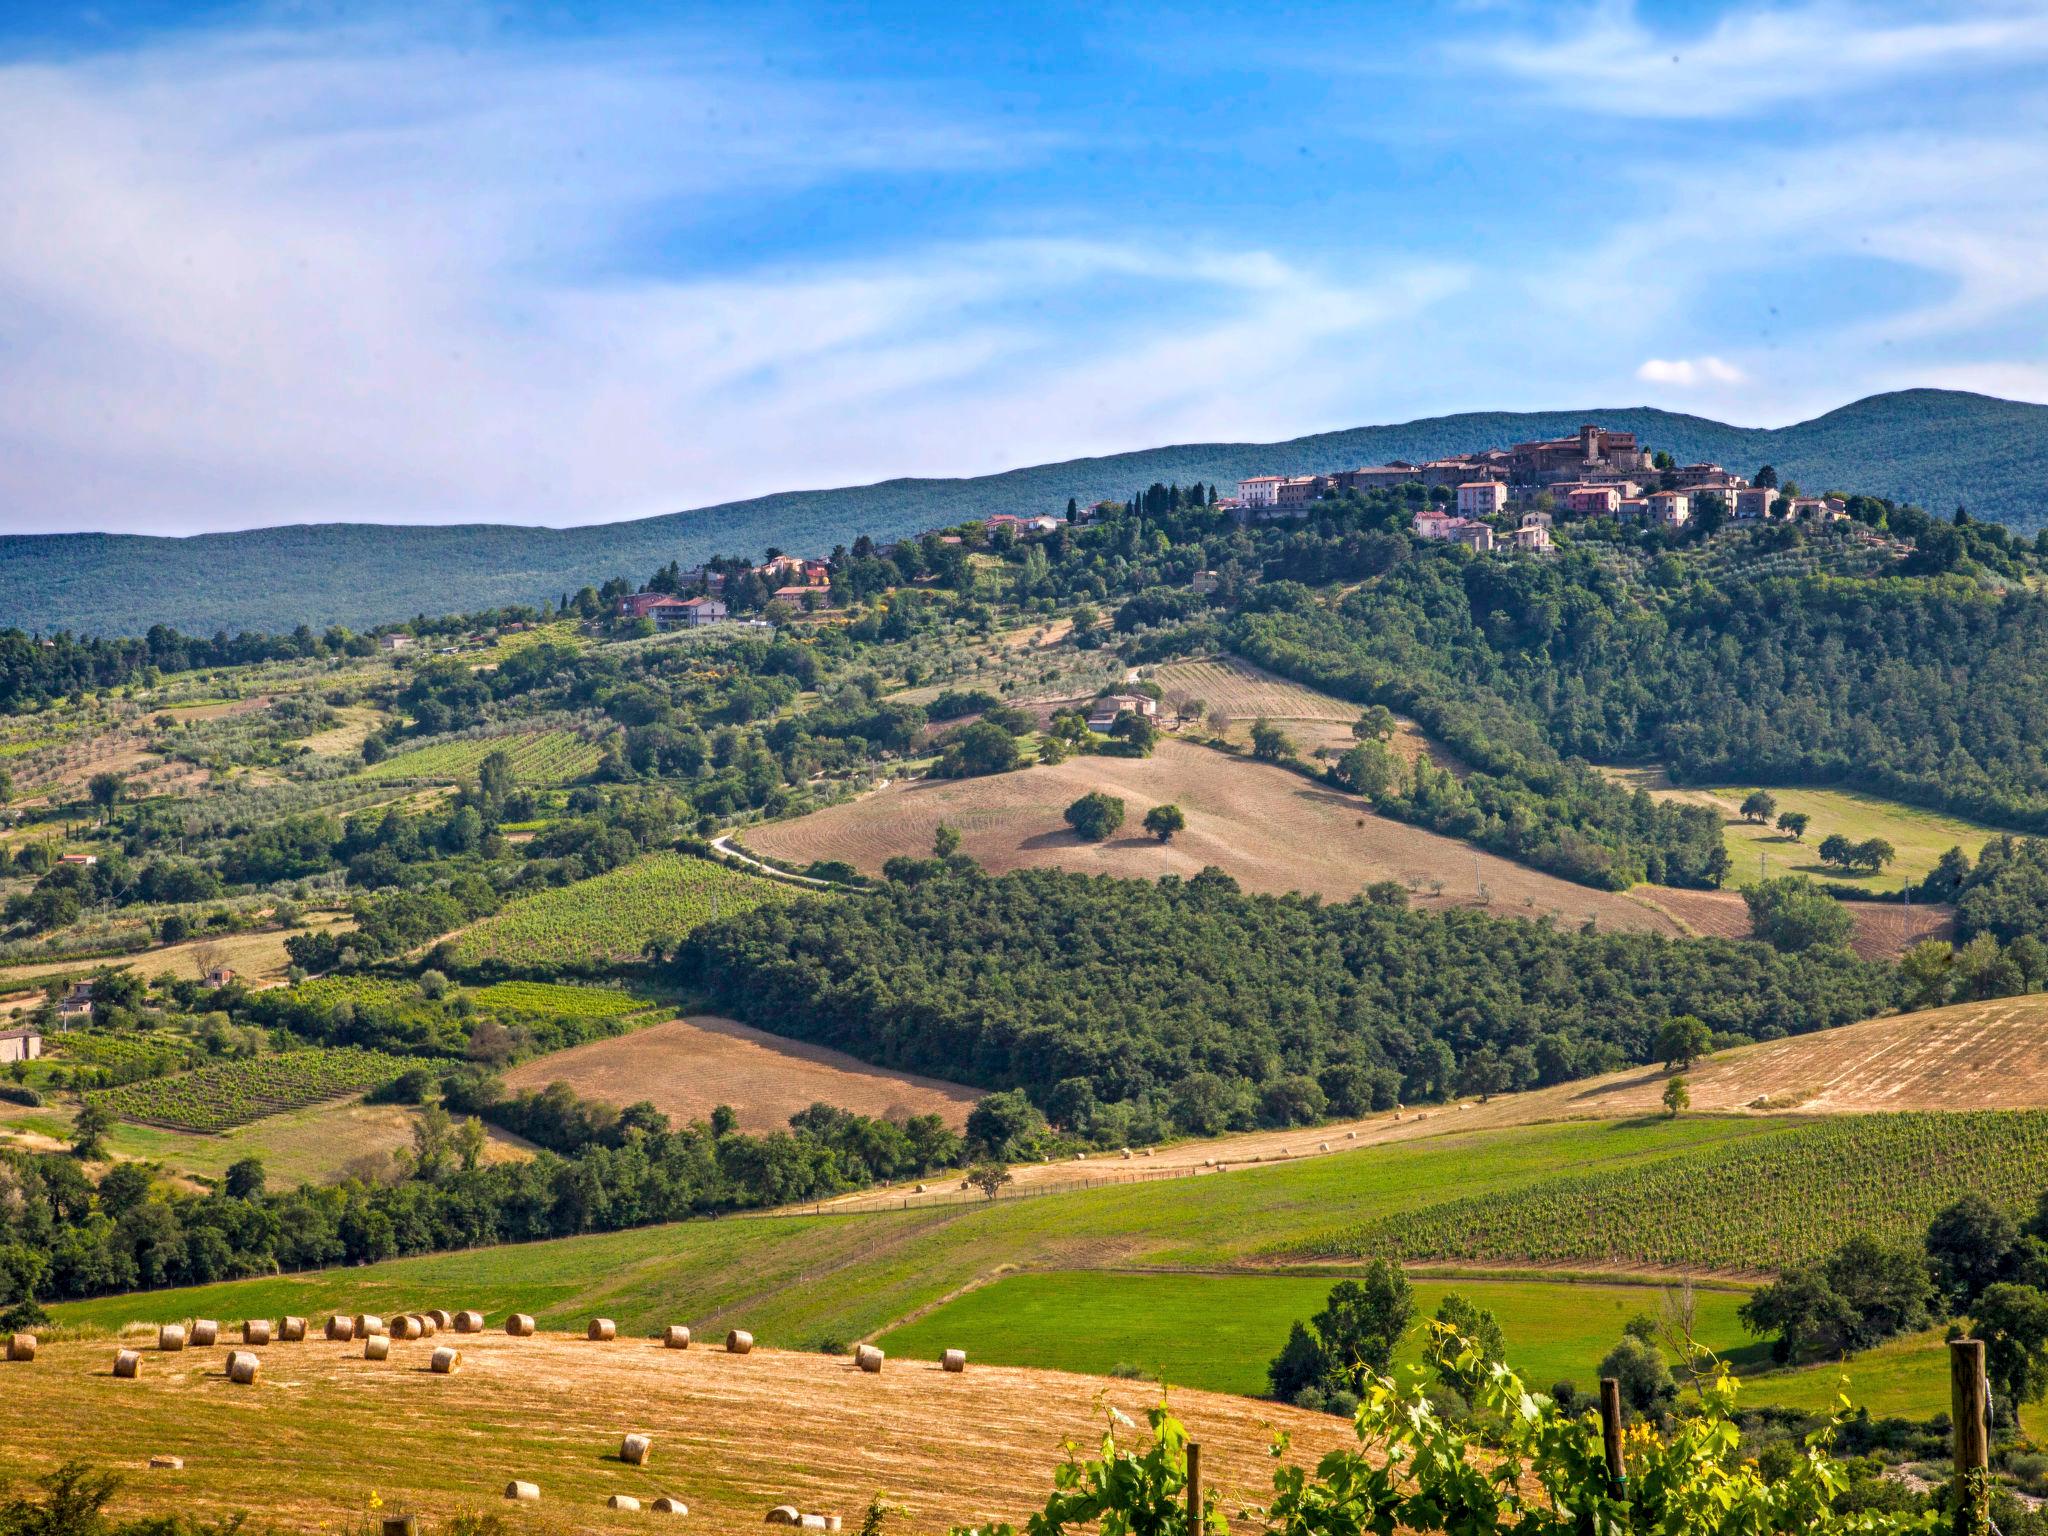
0,1327,1356,1534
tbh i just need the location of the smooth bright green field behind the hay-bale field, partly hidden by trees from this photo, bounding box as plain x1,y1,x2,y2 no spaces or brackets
877,1270,1765,1397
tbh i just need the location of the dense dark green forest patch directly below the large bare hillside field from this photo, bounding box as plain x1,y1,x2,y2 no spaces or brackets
674,868,1896,1141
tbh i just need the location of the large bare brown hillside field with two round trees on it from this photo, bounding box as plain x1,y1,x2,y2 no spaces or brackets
745,741,1679,934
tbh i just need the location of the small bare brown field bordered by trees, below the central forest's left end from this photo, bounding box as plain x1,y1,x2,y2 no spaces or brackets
506,1014,981,1133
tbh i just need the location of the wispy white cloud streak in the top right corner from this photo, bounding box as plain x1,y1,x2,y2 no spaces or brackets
1483,0,2048,119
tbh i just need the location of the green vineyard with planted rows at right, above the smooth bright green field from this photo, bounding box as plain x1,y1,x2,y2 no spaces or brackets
1325,1110,2048,1270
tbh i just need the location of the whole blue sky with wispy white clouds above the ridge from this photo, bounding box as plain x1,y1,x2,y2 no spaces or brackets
0,0,2048,532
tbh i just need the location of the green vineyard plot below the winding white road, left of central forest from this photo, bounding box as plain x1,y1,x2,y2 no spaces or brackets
455,854,795,973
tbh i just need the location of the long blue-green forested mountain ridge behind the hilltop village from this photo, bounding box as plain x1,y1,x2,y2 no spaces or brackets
0,389,2048,635
